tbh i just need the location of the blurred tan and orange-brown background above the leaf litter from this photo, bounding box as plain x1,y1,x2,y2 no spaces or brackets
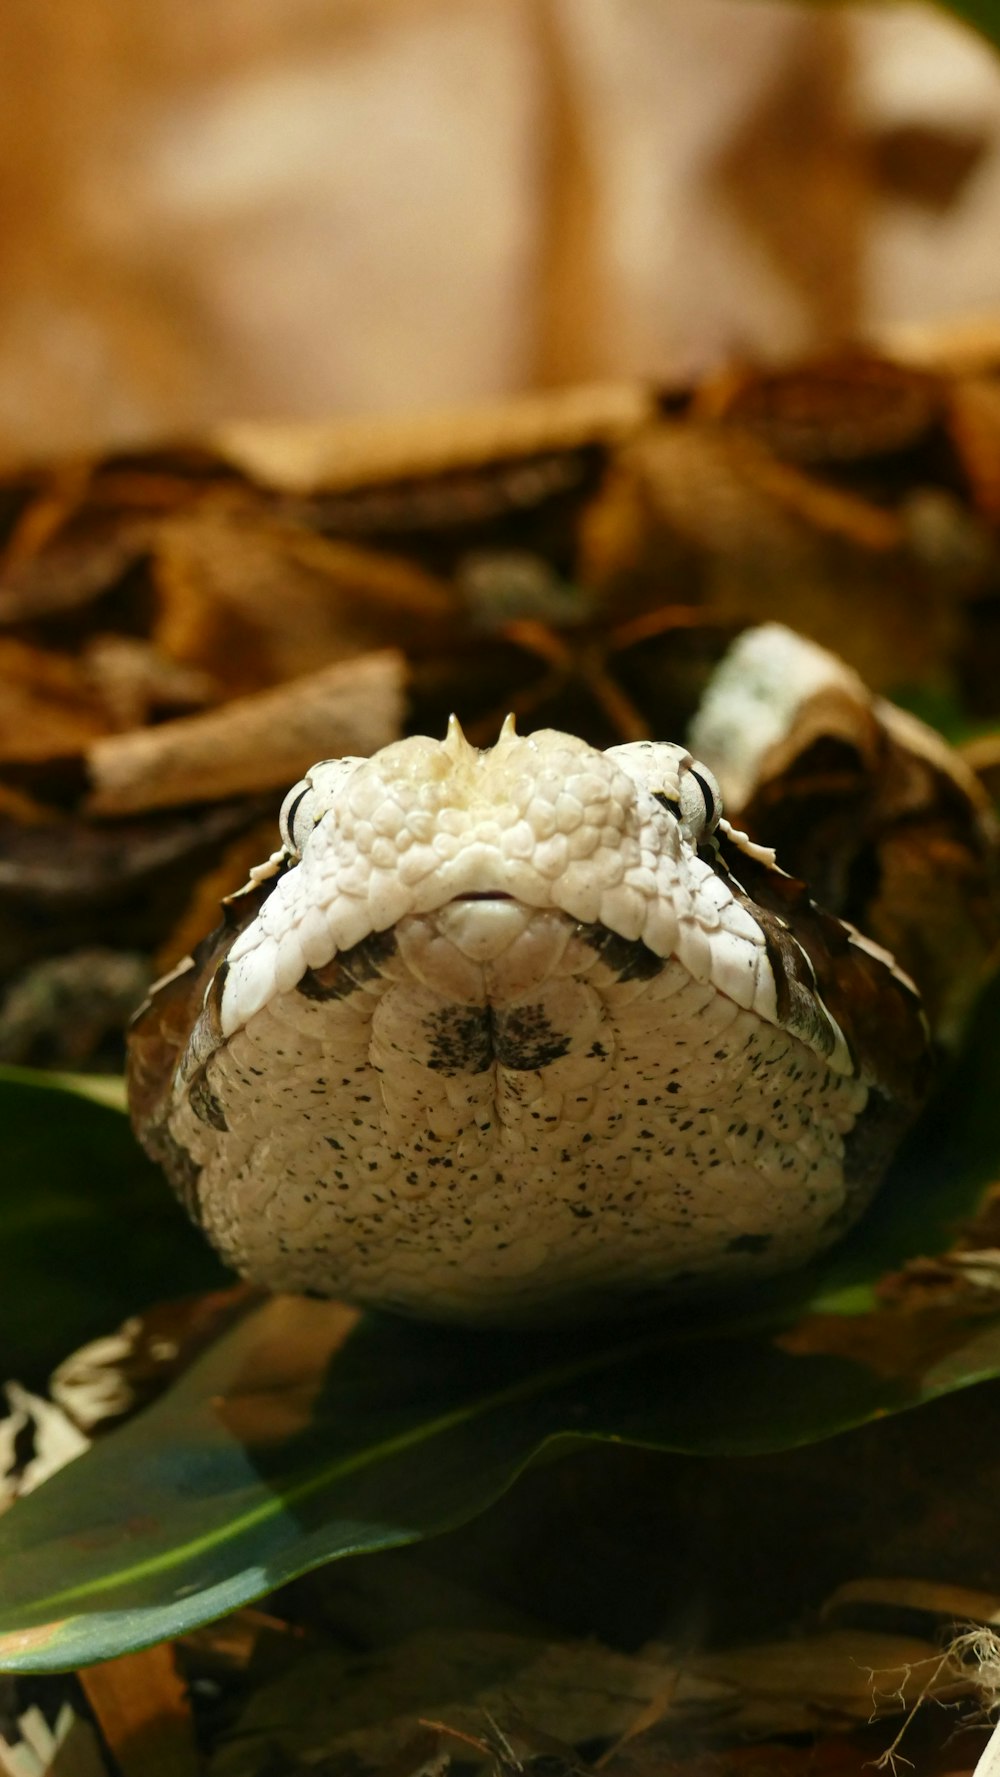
0,0,1000,458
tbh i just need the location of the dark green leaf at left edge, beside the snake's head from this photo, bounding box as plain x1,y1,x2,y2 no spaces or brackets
0,1068,227,1384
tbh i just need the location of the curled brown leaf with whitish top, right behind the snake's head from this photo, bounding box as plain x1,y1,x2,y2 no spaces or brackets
691,626,1000,1047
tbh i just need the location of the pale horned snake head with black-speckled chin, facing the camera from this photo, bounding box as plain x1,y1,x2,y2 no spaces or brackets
130,625,952,1326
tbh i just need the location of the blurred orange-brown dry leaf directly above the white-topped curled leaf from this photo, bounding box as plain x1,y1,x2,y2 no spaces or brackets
581,419,954,688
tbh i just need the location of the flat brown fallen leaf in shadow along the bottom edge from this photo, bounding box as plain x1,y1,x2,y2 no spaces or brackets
208,1630,973,1777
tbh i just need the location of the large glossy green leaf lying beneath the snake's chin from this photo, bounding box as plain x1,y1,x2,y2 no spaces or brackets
0,993,1000,1670
